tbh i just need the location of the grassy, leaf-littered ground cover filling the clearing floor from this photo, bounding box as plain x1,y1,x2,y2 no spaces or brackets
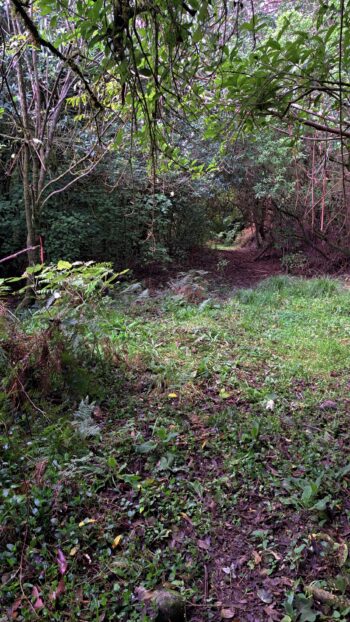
0,276,350,622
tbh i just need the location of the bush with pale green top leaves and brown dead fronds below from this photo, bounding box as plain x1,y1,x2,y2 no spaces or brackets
0,261,125,411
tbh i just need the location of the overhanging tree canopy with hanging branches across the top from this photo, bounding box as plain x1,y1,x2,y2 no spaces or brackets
1,0,350,266
